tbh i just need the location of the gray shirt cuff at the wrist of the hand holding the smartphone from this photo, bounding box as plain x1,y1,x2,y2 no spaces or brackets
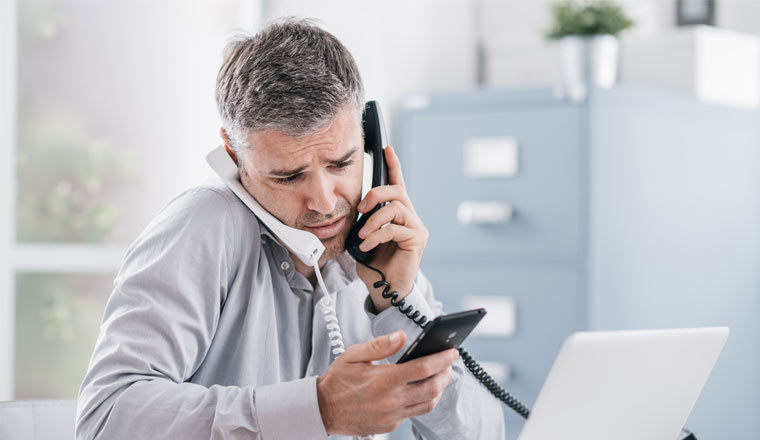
254,376,327,440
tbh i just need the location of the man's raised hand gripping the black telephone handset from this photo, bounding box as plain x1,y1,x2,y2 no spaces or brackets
356,147,428,312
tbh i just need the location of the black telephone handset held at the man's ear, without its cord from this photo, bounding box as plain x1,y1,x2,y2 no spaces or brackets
346,101,388,263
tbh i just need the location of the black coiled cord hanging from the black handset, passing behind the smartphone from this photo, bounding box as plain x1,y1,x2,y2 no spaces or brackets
361,262,530,419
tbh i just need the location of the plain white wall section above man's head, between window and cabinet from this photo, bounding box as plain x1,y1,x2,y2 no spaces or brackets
263,0,475,127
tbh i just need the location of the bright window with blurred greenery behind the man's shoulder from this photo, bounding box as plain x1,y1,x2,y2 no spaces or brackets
0,0,258,400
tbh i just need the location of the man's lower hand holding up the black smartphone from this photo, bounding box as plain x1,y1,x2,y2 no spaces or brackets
317,331,459,435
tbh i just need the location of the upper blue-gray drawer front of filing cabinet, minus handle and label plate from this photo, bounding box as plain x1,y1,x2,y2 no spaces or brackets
399,105,582,259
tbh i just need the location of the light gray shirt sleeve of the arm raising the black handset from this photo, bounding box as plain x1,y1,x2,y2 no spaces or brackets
365,272,505,440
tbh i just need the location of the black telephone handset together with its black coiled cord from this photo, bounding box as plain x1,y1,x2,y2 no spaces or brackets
346,101,530,419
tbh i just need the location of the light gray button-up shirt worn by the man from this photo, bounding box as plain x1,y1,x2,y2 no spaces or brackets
76,182,504,440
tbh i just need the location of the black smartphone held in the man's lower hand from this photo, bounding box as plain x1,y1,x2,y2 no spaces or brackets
397,309,486,364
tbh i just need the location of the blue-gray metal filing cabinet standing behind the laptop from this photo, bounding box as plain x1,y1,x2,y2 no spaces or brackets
392,87,760,440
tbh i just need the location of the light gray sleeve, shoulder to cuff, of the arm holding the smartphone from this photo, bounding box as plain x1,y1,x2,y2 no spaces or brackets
76,188,327,440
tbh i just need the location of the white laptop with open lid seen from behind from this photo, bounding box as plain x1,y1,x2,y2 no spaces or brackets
518,327,728,440
